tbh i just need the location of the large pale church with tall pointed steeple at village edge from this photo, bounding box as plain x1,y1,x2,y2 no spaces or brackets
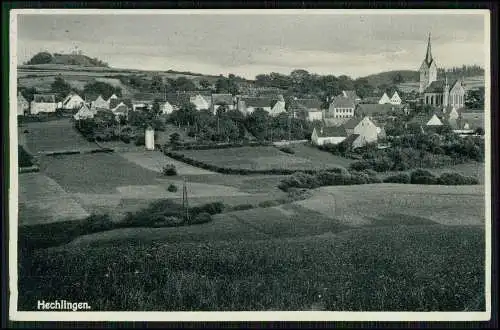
419,33,465,110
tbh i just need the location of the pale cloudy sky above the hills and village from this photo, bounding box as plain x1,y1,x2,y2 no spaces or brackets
17,10,489,79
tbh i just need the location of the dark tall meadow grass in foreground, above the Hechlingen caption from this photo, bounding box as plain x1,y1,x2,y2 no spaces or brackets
19,225,485,311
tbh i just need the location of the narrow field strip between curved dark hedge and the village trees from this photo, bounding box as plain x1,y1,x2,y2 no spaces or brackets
178,146,349,170
